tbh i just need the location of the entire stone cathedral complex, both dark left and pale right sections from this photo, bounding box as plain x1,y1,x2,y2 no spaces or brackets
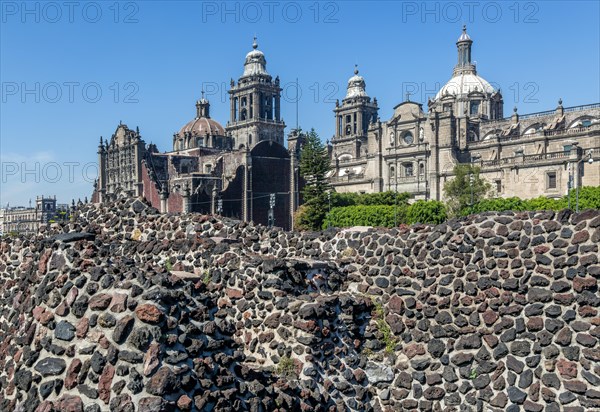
92,27,600,229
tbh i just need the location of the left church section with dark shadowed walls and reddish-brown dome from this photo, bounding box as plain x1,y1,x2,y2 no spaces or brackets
92,39,298,229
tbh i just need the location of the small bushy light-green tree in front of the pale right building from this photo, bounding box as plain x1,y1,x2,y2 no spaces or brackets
444,164,491,216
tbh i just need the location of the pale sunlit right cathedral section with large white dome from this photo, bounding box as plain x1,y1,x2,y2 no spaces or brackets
329,27,600,200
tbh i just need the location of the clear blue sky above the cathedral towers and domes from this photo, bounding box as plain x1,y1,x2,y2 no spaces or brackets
0,1,600,206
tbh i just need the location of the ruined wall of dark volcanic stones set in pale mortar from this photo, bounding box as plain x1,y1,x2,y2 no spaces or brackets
0,199,600,412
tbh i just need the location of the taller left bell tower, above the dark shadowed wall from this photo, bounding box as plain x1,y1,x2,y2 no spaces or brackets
225,37,285,150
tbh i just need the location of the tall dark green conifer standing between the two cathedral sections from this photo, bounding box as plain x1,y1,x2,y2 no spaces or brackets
298,129,331,230
